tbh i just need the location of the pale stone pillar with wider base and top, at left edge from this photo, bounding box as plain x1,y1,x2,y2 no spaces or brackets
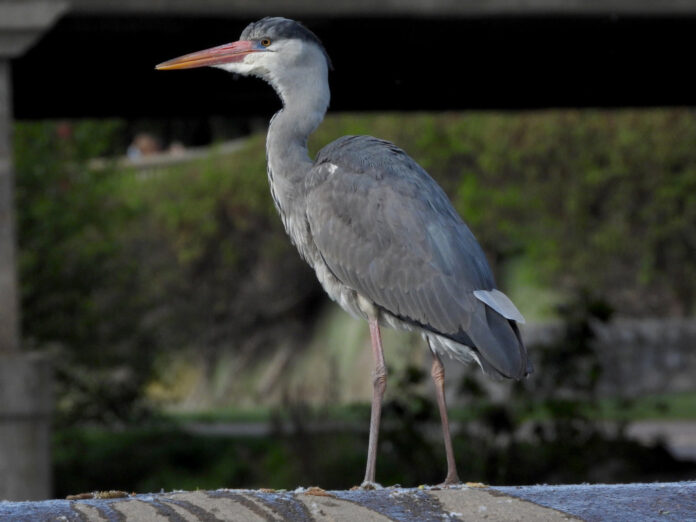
0,0,68,500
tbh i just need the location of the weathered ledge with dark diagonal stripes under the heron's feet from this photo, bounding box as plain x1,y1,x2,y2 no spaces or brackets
0,482,696,522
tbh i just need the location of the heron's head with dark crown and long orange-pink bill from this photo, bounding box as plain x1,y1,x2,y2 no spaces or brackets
157,17,331,95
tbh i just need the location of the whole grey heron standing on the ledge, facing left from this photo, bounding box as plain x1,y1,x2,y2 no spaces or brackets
157,17,532,486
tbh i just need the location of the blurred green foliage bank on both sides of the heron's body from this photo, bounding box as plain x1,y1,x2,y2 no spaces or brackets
14,109,696,421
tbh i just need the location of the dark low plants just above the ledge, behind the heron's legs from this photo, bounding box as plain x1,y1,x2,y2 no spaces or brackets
55,294,696,496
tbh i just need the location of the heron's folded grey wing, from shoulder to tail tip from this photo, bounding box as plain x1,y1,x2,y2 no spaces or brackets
307,136,526,377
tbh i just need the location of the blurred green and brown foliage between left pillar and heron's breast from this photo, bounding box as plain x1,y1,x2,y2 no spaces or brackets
14,121,320,424
